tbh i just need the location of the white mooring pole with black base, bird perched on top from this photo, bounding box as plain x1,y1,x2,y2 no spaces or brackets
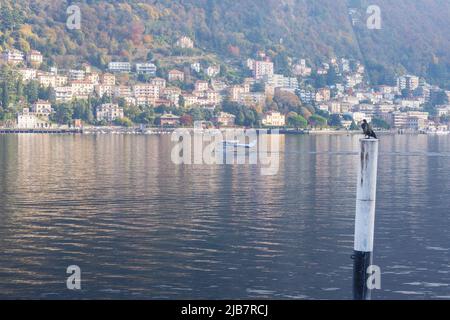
353,139,379,300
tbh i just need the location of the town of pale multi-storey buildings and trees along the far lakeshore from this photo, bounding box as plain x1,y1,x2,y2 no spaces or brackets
0,37,450,133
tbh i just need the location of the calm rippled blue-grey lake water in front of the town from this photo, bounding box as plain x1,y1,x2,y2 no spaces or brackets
0,135,450,299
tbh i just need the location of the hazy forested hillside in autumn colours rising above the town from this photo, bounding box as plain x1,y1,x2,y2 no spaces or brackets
0,0,450,85
